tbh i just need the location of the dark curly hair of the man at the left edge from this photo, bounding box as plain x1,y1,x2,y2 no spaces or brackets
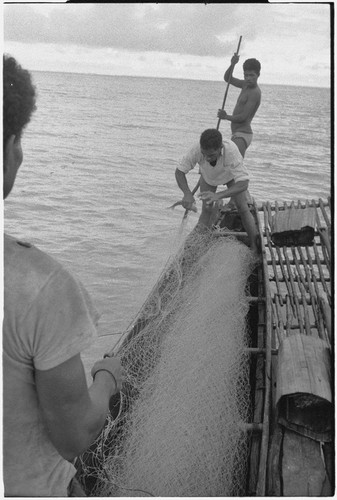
3,54,36,147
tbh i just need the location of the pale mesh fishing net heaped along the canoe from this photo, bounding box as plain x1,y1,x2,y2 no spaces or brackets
79,231,254,496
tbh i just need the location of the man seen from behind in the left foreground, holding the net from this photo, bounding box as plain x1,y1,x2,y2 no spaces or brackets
3,55,124,497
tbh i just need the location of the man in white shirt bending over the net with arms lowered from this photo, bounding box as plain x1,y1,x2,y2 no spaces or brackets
175,129,258,254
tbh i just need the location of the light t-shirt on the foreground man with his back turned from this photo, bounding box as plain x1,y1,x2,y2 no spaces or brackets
3,235,98,497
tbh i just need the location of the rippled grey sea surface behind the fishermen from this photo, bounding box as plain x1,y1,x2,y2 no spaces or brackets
4,71,331,374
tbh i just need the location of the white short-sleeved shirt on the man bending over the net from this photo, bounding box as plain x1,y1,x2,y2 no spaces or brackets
178,140,249,186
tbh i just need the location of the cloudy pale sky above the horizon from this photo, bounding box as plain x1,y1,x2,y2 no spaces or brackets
3,2,332,87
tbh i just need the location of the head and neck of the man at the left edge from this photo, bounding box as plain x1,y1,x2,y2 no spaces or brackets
3,55,36,198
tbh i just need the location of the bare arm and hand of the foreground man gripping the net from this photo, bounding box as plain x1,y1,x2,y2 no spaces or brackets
35,354,123,461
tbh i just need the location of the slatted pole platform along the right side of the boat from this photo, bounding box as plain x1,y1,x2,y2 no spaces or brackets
257,199,334,496
